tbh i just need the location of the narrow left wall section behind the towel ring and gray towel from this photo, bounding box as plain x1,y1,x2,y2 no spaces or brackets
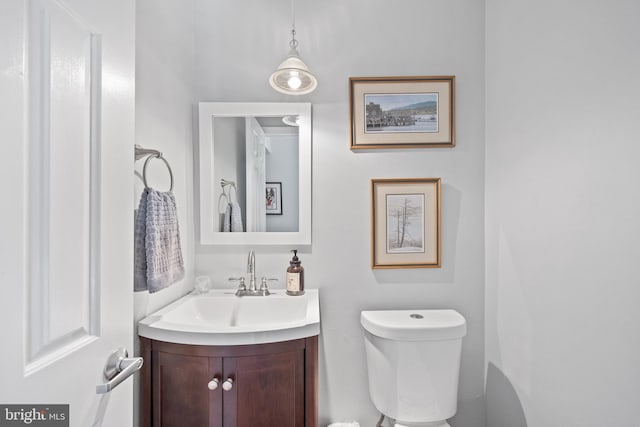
131,0,194,321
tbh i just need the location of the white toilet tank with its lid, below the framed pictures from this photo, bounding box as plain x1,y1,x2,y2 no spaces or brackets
360,310,467,427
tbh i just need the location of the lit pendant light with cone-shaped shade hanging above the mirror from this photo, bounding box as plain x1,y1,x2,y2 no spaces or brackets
269,0,318,95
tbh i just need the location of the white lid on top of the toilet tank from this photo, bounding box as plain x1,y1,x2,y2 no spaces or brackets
360,310,467,341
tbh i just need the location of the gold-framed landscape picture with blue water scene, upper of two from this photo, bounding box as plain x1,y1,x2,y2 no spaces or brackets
349,76,455,150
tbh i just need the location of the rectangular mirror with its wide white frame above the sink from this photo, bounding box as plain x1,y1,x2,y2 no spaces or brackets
198,102,311,245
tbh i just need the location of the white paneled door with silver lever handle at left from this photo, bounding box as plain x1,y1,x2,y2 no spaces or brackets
0,0,135,427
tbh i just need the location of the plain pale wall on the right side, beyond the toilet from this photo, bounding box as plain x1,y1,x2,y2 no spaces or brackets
486,0,640,427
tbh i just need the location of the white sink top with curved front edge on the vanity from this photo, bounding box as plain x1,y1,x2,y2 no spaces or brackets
138,289,320,345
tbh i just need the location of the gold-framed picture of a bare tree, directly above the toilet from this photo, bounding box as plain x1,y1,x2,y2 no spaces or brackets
371,178,442,269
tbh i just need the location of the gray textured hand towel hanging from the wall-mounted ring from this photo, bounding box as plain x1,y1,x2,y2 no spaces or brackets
134,188,184,293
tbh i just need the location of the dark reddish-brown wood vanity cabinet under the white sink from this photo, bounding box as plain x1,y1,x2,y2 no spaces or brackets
140,336,318,427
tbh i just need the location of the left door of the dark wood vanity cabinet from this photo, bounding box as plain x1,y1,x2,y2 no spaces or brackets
152,352,222,427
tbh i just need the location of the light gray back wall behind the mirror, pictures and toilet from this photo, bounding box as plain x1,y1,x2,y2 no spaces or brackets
195,0,484,427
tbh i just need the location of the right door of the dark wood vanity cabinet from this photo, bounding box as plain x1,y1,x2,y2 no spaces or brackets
224,350,305,427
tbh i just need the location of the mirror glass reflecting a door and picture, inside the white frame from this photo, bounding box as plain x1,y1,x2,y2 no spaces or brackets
213,116,299,232
